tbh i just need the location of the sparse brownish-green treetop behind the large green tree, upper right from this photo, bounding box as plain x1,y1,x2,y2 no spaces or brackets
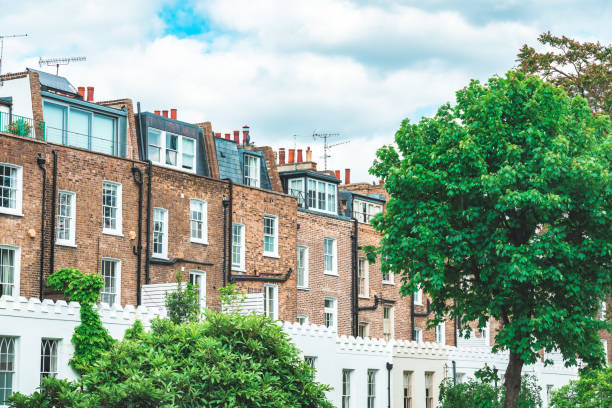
517,32,612,115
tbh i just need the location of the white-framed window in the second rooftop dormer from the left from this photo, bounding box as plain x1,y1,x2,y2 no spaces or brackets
147,127,195,172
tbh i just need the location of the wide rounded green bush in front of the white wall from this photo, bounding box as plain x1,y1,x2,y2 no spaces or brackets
8,310,332,408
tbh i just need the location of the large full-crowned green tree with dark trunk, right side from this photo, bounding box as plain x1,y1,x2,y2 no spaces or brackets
370,72,612,407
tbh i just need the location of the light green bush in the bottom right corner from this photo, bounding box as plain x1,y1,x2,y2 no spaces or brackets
550,366,612,408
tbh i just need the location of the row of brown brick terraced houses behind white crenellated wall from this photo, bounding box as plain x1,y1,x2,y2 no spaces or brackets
0,69,612,400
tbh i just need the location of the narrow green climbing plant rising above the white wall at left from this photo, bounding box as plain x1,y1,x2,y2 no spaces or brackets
47,268,115,374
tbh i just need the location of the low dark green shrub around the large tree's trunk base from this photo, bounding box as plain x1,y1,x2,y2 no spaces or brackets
440,370,542,408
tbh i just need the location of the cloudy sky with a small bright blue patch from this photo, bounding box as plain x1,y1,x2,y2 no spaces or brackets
0,0,612,181
